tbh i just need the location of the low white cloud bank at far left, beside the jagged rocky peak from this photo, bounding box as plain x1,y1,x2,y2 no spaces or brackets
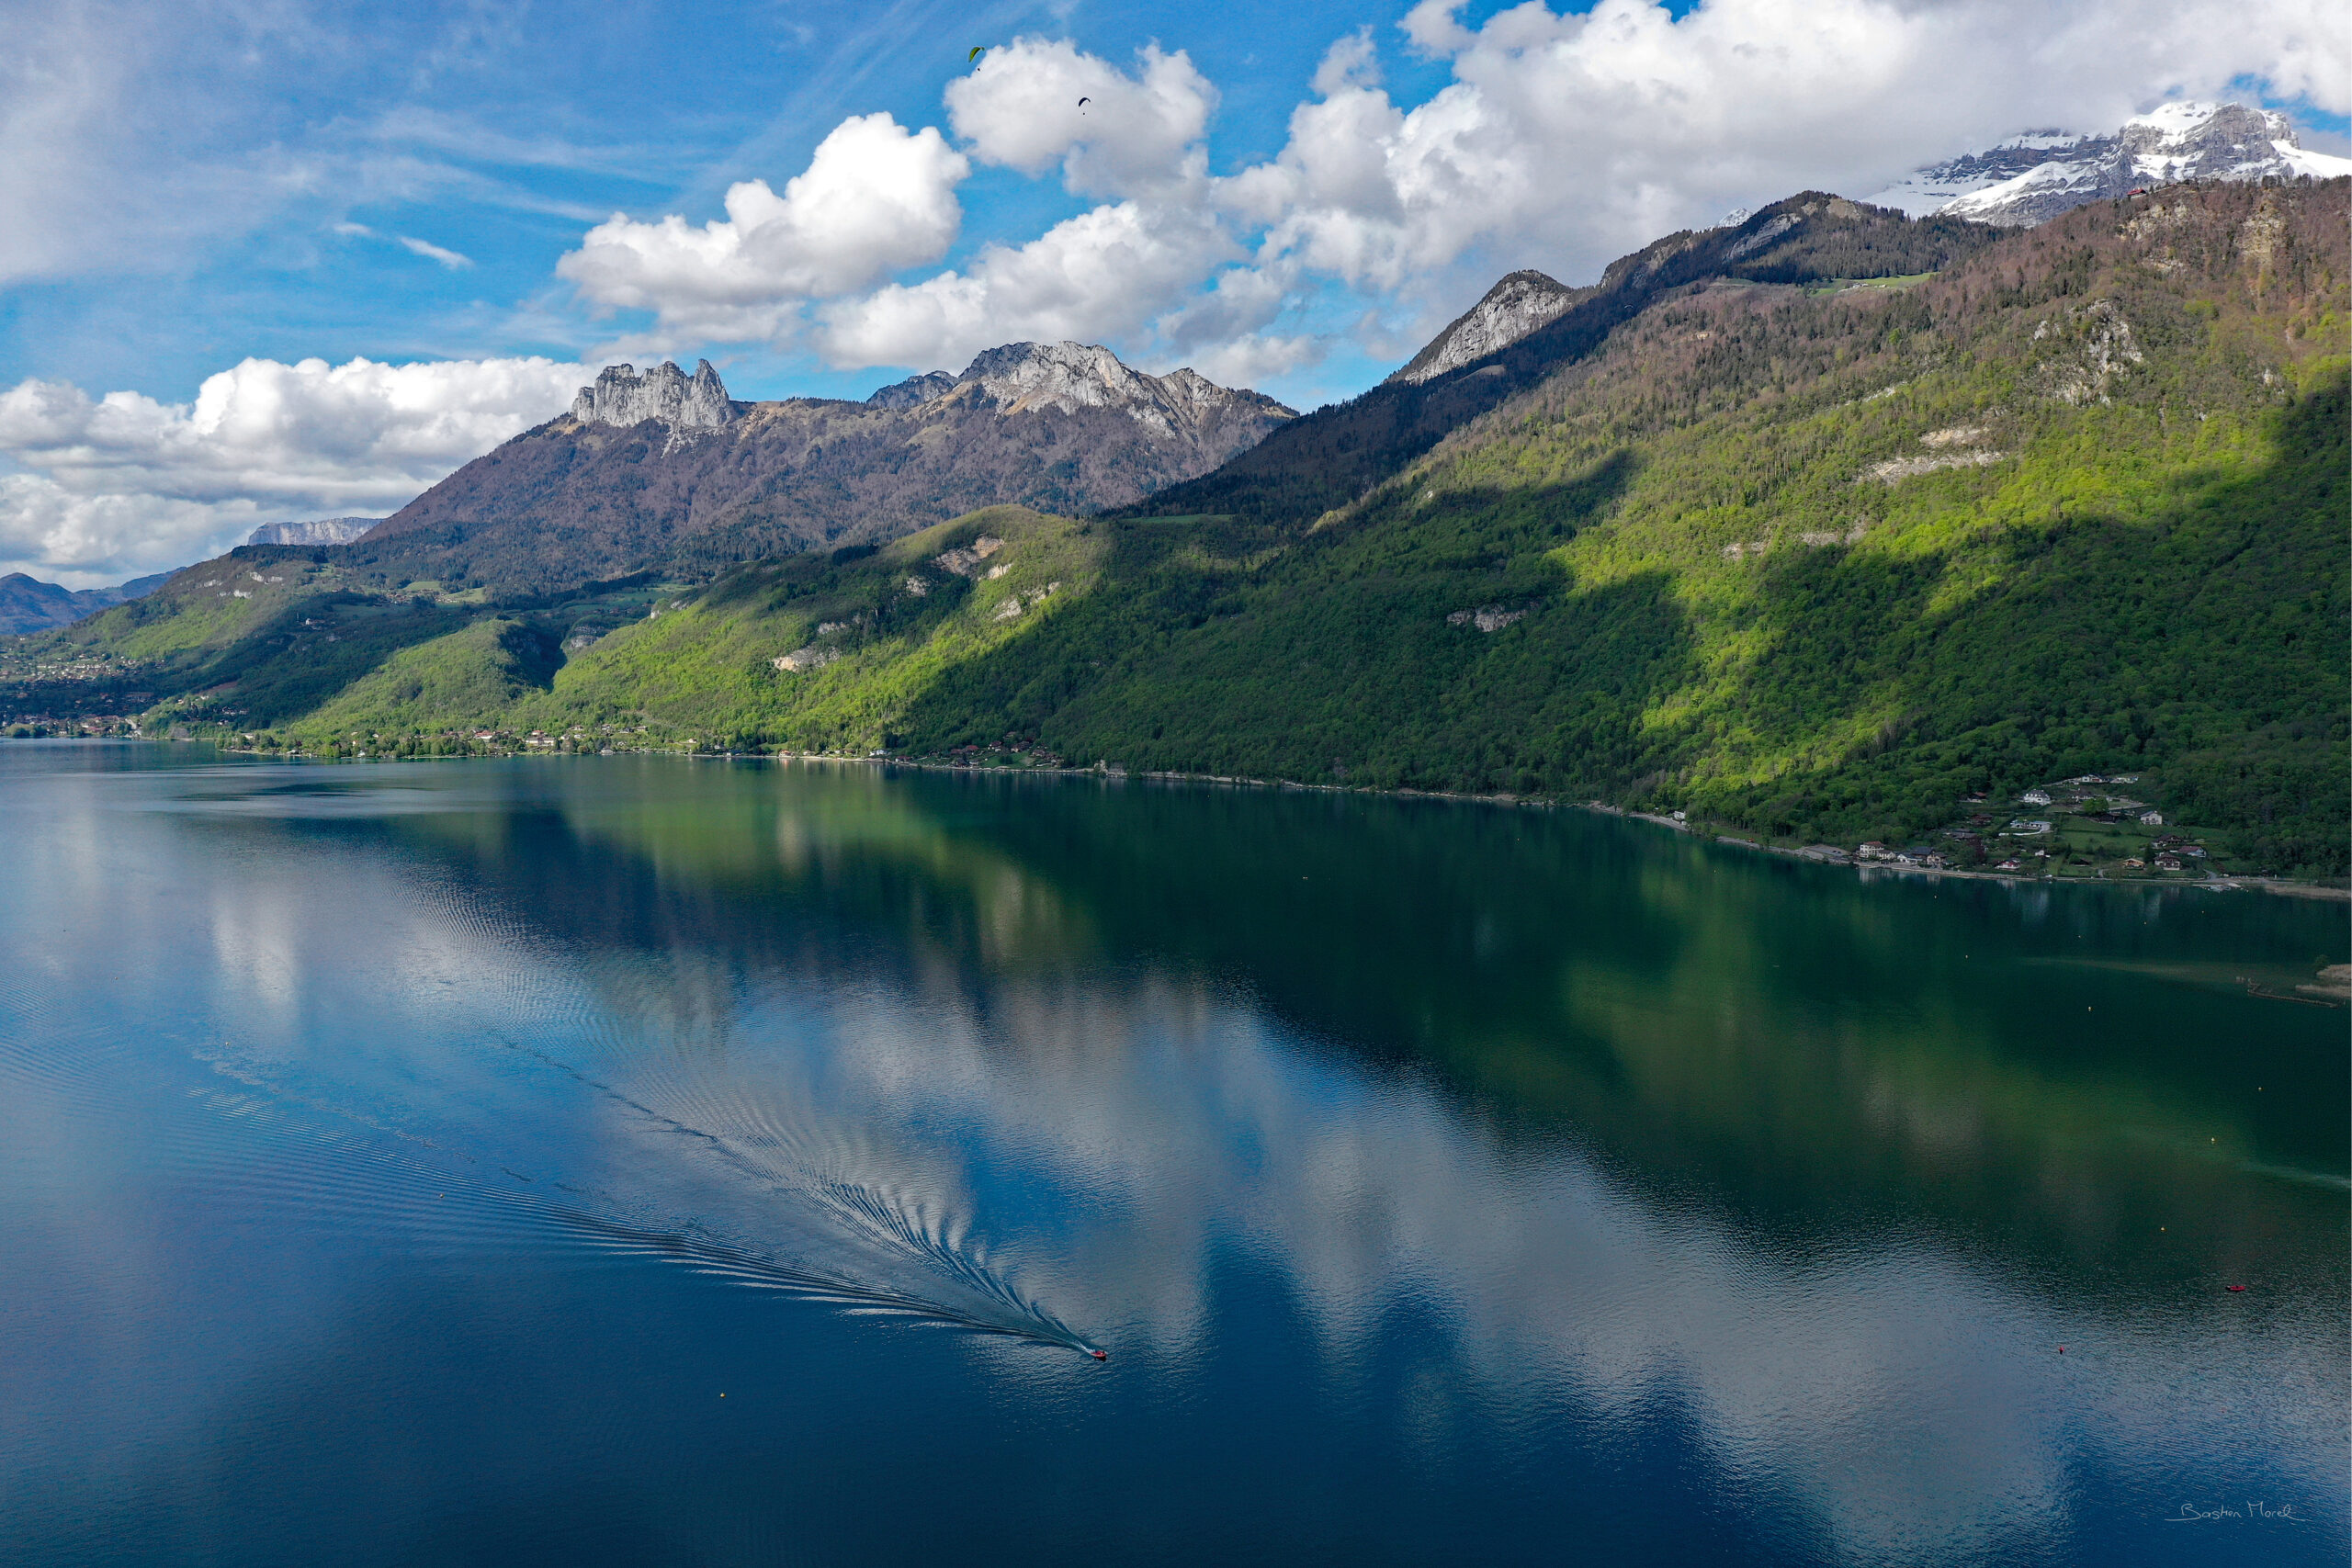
0,357,595,588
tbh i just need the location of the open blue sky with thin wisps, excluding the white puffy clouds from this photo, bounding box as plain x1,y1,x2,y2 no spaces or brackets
0,0,1496,411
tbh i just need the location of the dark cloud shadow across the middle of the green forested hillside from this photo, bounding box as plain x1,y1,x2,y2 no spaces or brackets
887,454,1656,790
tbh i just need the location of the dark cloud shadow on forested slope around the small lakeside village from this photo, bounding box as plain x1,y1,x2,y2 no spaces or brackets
1710,376,2352,867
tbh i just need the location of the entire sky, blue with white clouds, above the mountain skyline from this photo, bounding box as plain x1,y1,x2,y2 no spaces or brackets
0,0,2352,585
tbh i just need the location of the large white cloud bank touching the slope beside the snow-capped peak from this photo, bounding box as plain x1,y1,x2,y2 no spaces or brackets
1230,0,2352,303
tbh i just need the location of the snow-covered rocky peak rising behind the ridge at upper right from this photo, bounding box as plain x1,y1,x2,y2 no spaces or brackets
1870,104,2352,228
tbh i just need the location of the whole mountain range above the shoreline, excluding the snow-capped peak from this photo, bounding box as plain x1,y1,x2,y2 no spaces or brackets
18,176,2352,874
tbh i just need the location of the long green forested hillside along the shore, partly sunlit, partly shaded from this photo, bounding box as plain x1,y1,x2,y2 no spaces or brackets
9,181,2352,874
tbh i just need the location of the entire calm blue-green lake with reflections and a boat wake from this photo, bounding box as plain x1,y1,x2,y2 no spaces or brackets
0,743,2347,1568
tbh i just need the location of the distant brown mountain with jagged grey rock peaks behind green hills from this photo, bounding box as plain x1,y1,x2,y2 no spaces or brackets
336,344,1294,592
